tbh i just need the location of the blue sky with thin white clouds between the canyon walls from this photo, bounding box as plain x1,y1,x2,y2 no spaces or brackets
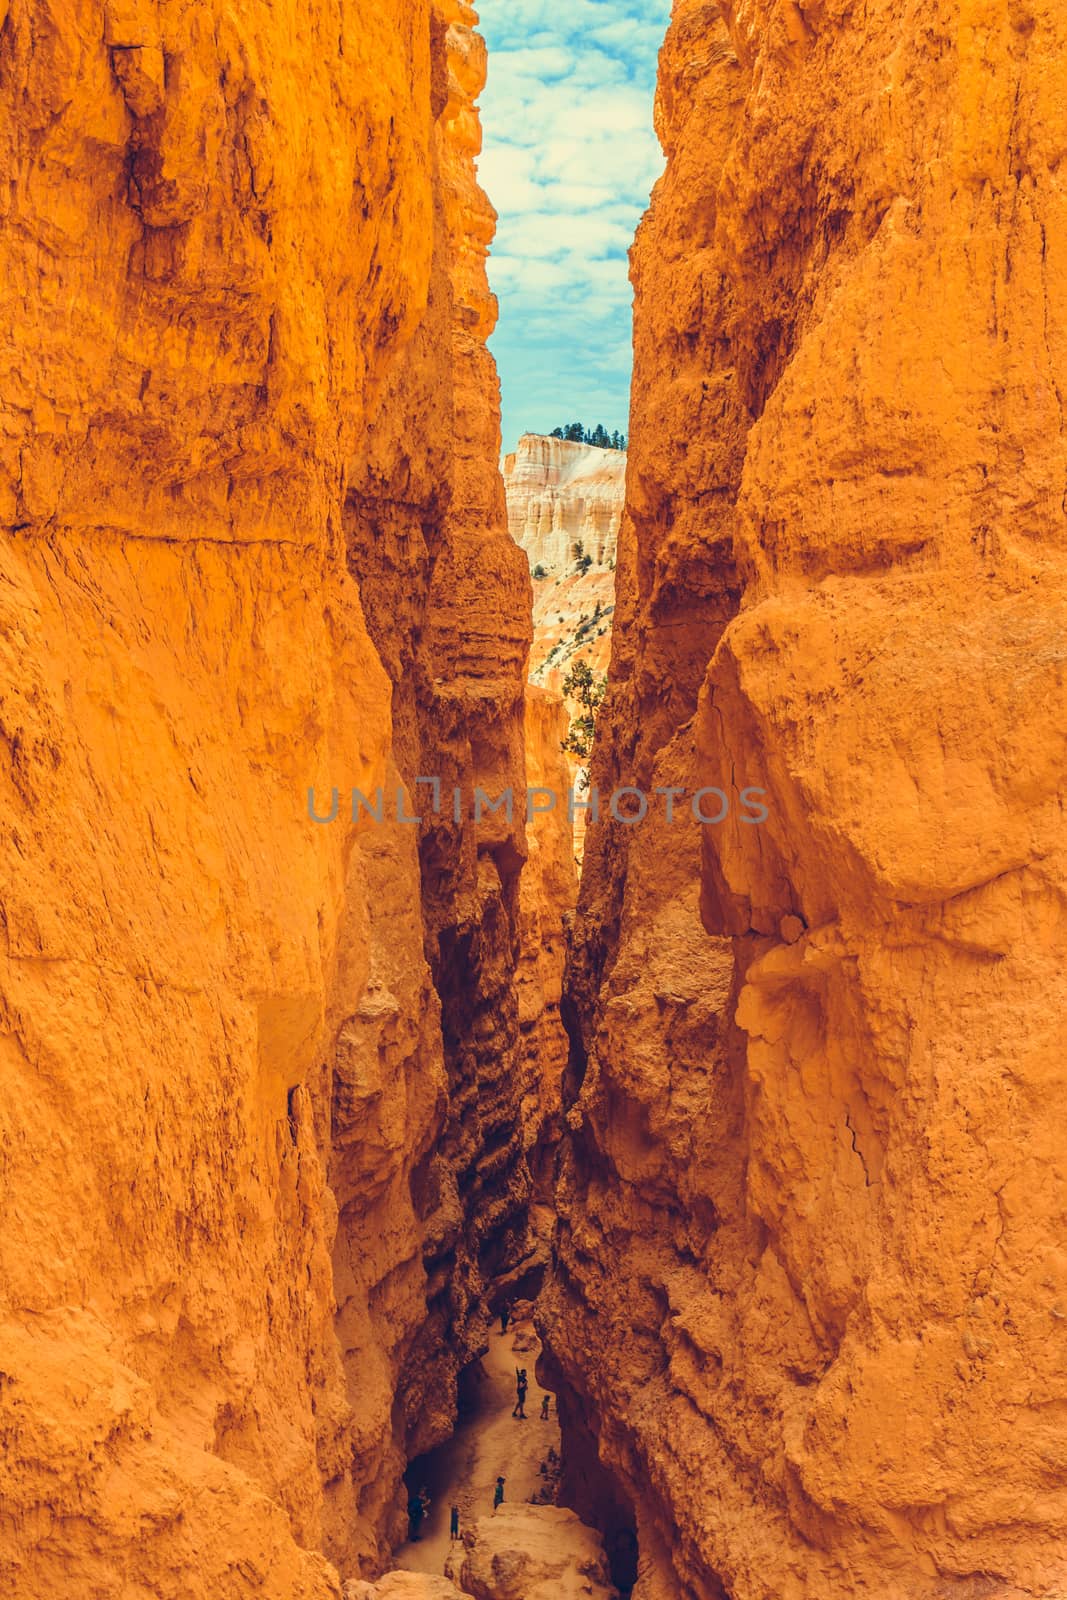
475,0,670,450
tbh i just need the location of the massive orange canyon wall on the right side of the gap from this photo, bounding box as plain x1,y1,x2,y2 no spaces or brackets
541,0,1067,1600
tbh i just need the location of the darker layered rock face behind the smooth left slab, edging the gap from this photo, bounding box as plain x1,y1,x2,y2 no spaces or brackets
338,0,543,1536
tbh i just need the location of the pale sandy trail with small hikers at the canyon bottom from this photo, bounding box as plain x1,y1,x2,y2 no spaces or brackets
394,1320,560,1574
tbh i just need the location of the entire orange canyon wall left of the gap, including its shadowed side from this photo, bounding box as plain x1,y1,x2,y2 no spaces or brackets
0,0,536,1600
